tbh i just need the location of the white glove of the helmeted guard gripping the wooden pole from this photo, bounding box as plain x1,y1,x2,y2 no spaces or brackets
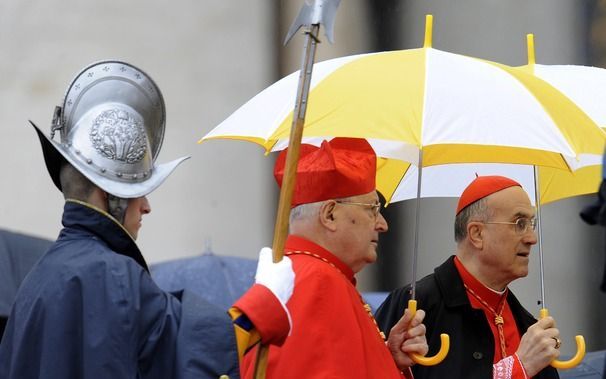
255,247,295,305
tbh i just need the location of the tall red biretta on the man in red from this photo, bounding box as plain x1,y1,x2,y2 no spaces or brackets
274,138,377,207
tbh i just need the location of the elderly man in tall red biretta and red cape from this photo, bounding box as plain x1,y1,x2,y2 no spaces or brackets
242,138,427,379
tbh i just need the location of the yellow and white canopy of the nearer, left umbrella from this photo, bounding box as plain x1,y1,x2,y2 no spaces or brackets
202,17,604,185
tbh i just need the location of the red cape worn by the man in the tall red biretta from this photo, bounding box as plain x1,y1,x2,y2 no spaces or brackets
241,236,404,379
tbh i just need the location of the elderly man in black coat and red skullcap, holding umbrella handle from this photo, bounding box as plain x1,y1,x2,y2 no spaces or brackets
376,176,560,379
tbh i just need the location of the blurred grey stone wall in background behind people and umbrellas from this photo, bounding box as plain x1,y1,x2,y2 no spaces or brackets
0,0,606,354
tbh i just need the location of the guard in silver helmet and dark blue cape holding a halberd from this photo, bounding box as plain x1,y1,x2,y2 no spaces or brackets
0,60,294,379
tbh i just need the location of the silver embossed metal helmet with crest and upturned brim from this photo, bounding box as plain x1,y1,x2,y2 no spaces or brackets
32,61,188,198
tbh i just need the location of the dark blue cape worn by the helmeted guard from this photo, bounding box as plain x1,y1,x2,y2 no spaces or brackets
0,201,239,379
